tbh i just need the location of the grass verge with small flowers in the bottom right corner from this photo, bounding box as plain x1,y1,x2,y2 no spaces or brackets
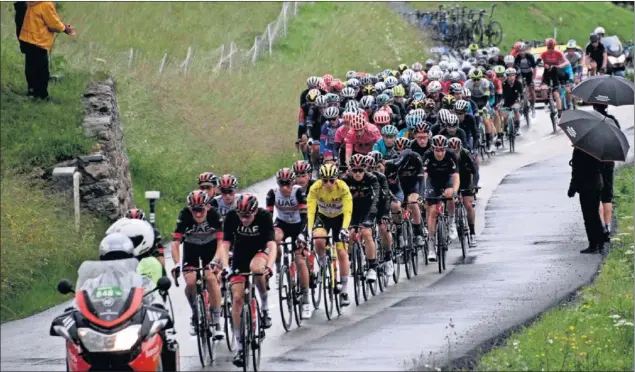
476,166,634,371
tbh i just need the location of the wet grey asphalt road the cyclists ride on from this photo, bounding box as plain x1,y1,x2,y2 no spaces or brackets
0,106,633,370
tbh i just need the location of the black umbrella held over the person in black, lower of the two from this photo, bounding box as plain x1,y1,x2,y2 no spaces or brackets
558,110,630,161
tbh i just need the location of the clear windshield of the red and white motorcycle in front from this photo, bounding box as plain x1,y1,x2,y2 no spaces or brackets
76,258,145,321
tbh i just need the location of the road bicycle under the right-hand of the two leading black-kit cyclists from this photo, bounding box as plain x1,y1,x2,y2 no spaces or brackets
228,271,265,372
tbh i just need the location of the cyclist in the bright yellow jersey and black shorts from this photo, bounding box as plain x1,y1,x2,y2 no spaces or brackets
307,164,353,306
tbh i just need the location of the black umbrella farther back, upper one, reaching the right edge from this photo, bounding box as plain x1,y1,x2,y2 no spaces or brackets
571,75,635,106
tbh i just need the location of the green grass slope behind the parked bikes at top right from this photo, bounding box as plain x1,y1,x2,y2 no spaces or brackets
409,1,633,51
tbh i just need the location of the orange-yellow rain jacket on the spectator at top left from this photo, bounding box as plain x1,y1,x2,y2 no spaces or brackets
20,1,66,52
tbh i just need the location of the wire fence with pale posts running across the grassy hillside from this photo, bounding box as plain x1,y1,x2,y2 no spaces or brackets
59,1,313,77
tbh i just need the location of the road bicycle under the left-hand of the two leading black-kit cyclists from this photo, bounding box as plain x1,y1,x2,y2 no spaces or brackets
174,257,220,367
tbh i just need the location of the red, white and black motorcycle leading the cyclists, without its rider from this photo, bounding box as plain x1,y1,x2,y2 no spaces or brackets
49,259,179,371
